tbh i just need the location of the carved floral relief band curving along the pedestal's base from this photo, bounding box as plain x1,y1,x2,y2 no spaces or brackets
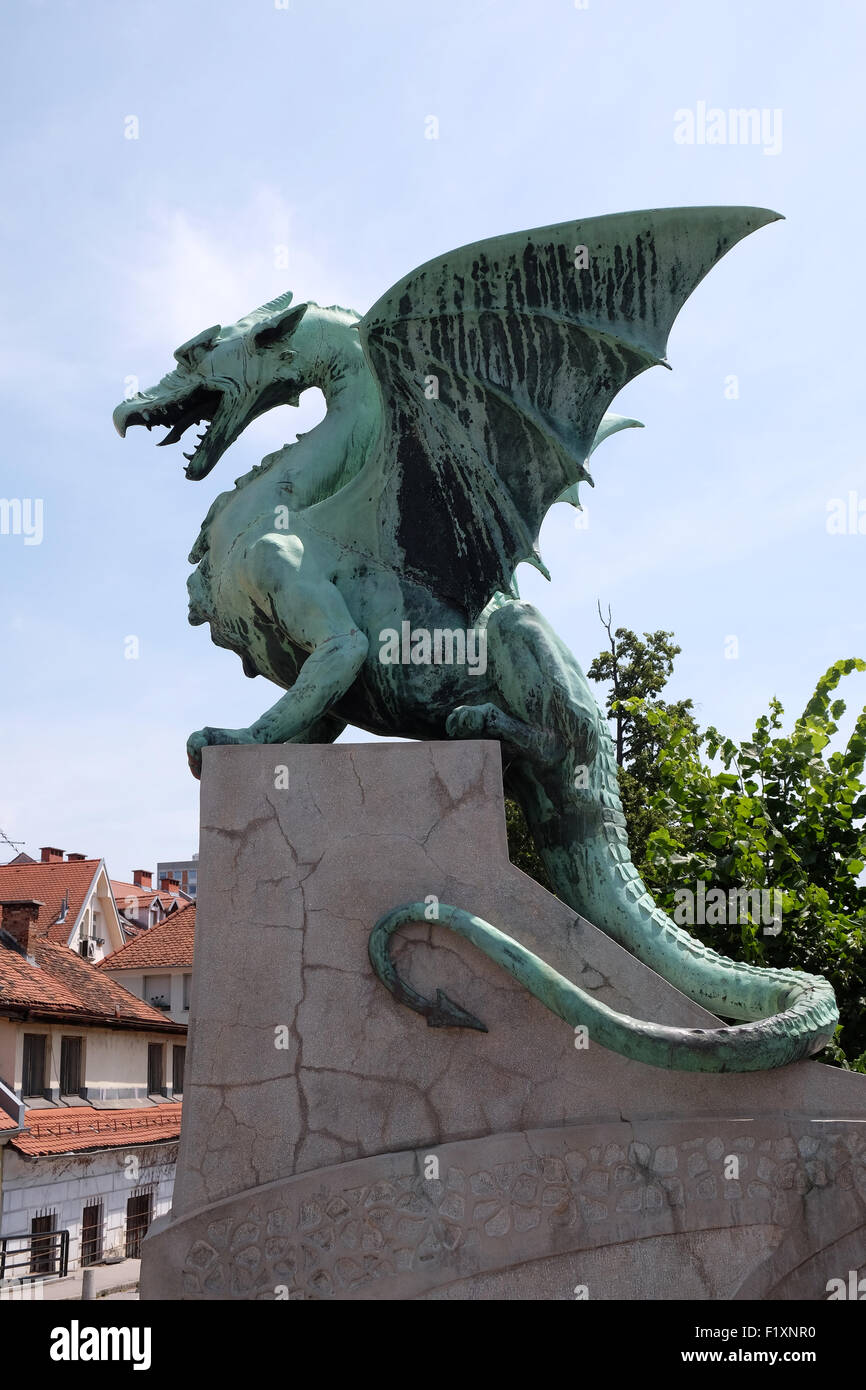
176,1127,866,1300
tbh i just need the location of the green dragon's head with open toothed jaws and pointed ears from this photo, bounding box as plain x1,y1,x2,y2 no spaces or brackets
114,292,328,480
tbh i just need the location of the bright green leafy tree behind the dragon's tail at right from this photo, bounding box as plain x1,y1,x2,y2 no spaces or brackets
619,657,866,1072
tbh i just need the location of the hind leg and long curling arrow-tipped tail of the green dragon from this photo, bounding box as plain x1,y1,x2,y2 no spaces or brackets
408,600,838,1072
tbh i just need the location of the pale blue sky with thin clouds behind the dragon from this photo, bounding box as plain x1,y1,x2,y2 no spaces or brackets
0,0,866,877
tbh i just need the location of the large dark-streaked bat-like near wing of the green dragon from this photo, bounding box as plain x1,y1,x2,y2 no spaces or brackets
359,207,780,620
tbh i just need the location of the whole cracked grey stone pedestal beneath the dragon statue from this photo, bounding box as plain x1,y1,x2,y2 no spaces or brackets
142,742,866,1300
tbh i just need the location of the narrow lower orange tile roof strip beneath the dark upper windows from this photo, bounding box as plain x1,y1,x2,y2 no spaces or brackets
8,1101,181,1156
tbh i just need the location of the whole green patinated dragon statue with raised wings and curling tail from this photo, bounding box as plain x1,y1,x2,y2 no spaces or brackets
114,207,838,1072
